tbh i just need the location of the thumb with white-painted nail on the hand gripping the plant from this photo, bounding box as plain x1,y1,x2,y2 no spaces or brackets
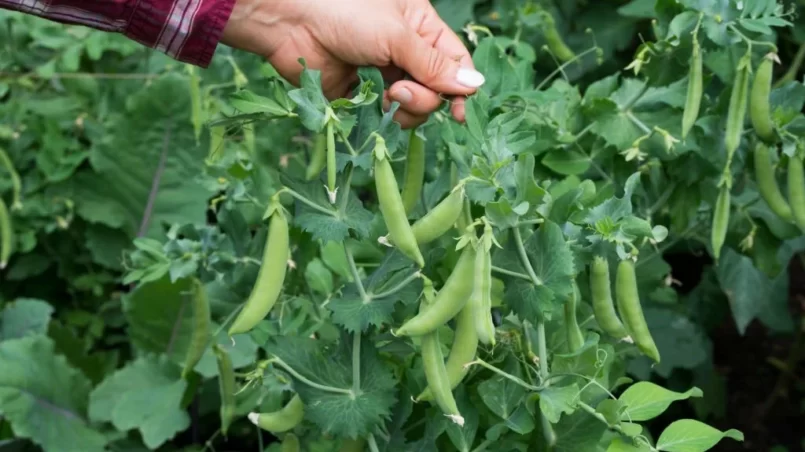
391,28,485,96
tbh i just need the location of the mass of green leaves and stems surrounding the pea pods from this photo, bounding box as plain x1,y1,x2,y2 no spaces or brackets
0,0,805,452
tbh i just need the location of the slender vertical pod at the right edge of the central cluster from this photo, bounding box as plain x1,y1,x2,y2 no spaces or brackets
470,223,495,345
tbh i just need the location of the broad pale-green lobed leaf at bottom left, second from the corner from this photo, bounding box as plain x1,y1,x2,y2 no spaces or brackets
89,355,190,450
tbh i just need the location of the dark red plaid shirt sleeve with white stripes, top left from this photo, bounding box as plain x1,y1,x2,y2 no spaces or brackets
0,0,235,67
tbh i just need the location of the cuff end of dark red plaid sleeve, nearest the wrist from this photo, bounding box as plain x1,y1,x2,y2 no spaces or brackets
123,0,235,68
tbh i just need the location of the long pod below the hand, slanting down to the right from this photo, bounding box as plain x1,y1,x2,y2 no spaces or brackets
374,136,425,268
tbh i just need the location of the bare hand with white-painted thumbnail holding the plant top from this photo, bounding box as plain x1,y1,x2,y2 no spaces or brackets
222,0,484,128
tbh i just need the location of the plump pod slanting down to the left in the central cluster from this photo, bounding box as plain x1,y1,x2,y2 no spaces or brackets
394,246,475,336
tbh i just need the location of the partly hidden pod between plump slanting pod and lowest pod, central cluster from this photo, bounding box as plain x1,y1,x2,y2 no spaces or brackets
416,303,478,402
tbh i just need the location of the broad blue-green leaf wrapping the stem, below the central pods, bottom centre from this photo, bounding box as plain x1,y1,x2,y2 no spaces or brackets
266,335,397,438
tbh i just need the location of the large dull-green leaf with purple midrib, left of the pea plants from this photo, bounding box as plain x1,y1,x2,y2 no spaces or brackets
65,73,212,238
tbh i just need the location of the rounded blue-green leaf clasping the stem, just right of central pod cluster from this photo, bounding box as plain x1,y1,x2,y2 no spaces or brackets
493,221,576,320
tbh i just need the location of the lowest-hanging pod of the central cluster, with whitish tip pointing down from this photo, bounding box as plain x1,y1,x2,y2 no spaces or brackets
419,284,464,426
